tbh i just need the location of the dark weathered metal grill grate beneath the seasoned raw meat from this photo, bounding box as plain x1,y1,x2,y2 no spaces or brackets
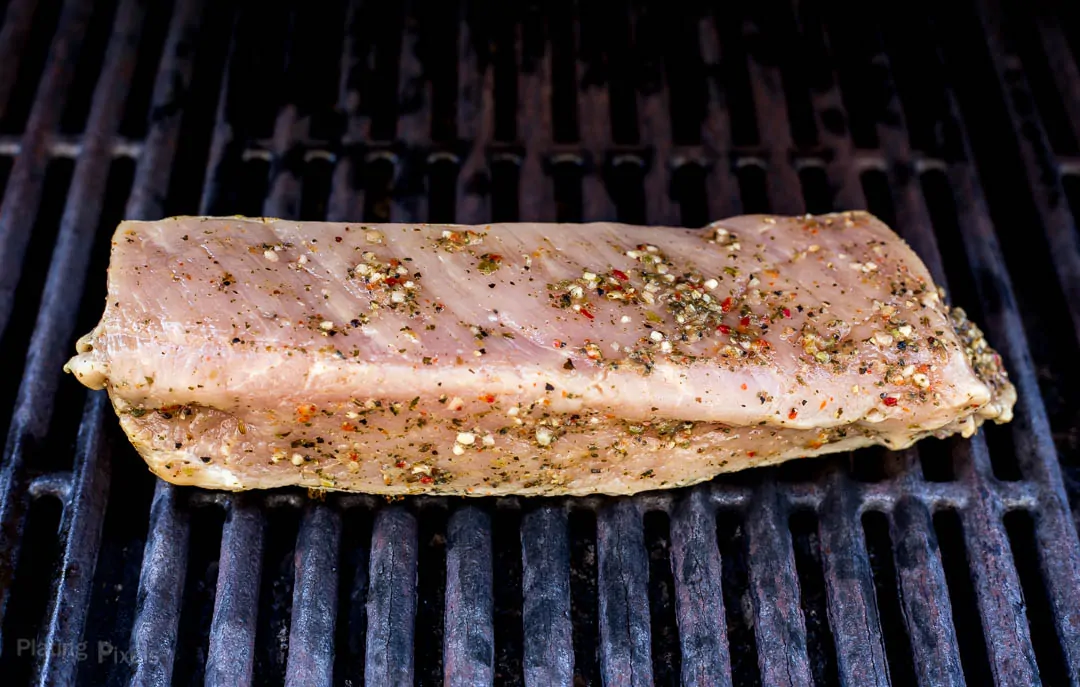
0,0,1080,686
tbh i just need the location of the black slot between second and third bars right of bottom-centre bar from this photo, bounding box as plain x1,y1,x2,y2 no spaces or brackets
716,510,761,687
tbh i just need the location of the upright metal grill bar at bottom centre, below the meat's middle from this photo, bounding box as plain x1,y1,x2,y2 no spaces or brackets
522,506,573,687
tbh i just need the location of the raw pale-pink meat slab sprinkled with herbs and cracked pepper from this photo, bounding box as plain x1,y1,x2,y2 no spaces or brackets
66,212,1015,496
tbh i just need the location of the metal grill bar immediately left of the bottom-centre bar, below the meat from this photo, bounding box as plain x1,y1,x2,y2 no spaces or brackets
443,507,495,685
